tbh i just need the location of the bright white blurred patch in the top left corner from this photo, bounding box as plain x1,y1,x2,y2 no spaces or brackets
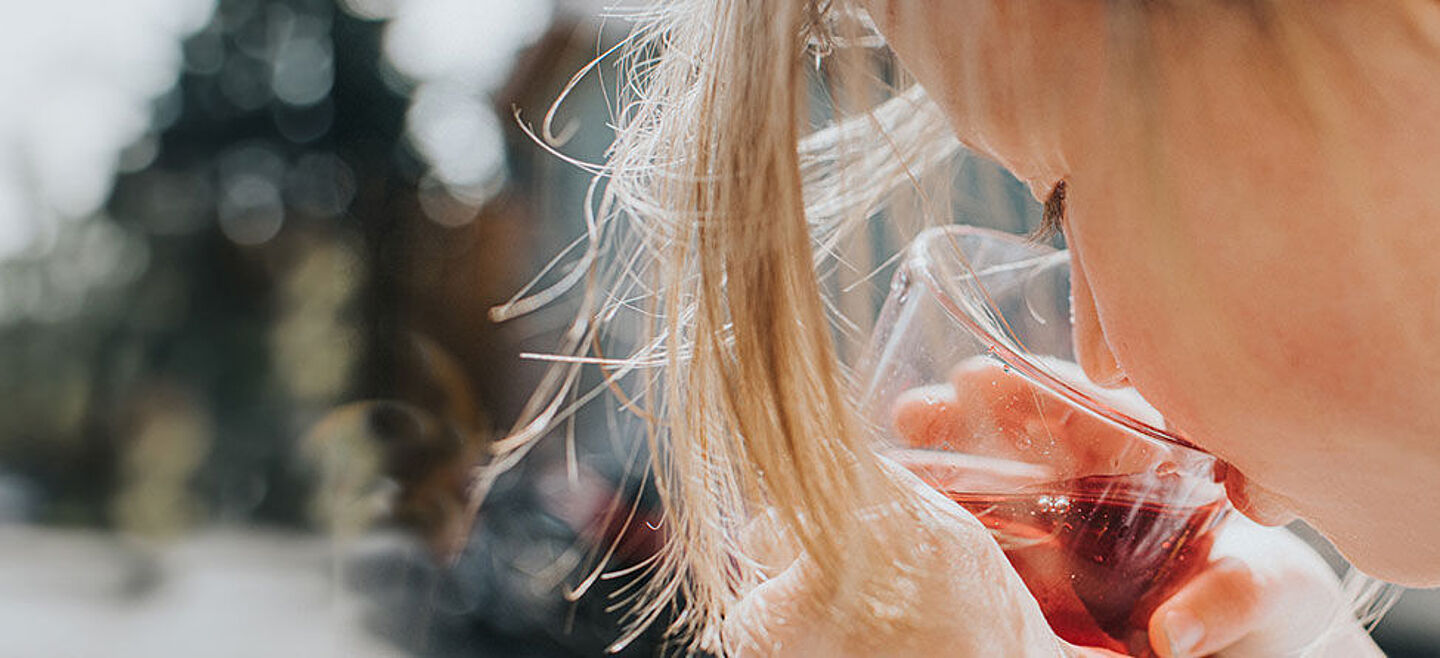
0,0,215,258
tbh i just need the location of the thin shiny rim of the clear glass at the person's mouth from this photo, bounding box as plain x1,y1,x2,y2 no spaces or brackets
901,225,1214,456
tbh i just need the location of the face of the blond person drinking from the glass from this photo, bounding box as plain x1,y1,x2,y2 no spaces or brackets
870,0,1440,585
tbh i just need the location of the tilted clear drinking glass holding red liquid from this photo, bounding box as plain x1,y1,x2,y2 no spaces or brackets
861,226,1228,657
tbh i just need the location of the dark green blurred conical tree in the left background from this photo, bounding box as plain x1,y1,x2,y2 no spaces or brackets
0,0,419,524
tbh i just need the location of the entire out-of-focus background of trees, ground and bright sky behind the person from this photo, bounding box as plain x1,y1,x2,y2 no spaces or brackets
0,0,1440,658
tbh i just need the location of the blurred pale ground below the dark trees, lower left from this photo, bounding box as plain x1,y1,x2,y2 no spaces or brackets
0,527,406,658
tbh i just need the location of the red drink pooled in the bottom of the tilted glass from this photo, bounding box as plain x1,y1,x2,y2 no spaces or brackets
940,474,1225,655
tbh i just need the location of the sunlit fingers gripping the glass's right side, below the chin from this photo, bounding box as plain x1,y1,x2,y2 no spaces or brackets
1149,518,1384,658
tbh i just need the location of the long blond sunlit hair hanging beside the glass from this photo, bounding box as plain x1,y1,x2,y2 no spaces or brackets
477,0,1393,654
